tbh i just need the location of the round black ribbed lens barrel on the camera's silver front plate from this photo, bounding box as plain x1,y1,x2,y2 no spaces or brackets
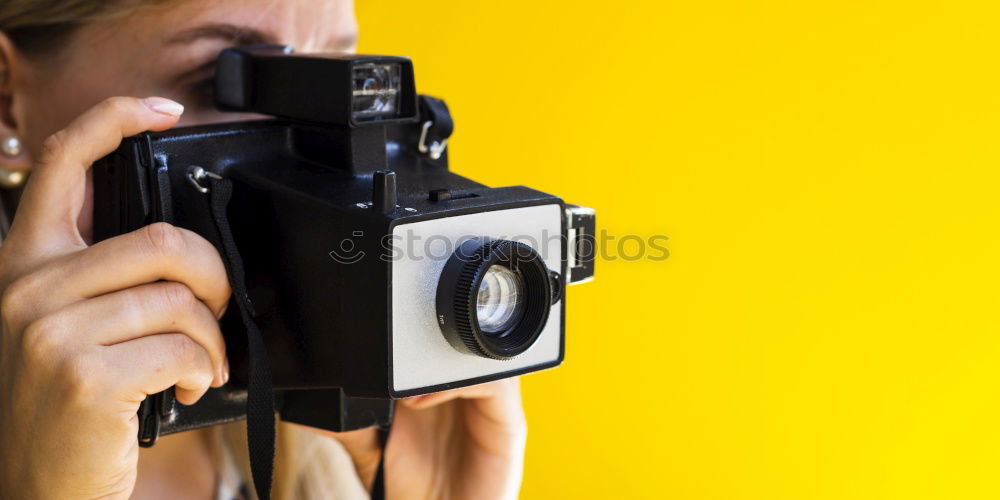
437,240,559,359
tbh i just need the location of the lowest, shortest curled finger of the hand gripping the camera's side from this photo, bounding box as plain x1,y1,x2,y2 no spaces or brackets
103,333,214,405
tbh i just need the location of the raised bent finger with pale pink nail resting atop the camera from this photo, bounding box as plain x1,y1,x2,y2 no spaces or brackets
11,97,184,242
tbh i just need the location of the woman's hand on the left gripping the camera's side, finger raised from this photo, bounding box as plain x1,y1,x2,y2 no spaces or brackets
0,97,230,498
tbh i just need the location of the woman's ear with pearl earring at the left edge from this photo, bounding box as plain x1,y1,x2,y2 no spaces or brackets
0,32,31,172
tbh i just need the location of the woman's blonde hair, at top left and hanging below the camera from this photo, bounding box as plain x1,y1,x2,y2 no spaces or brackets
0,0,367,499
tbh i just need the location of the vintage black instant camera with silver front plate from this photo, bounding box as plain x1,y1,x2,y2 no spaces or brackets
93,46,594,445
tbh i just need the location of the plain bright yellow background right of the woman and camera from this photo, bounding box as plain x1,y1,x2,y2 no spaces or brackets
358,0,1000,500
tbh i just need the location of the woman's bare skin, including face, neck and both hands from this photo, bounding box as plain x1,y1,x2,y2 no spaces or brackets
0,0,526,498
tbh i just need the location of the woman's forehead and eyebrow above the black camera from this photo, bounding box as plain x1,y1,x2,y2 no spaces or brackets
39,0,357,102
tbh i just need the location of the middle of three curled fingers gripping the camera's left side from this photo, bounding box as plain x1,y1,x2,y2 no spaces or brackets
46,281,229,387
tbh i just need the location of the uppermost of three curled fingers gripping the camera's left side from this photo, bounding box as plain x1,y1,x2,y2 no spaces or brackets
33,222,230,317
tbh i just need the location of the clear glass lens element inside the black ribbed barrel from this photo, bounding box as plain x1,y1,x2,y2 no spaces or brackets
476,264,524,335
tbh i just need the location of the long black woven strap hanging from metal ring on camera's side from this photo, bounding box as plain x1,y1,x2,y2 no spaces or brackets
209,175,275,500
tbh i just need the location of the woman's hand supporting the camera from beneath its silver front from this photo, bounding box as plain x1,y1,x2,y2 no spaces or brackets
321,378,527,499
